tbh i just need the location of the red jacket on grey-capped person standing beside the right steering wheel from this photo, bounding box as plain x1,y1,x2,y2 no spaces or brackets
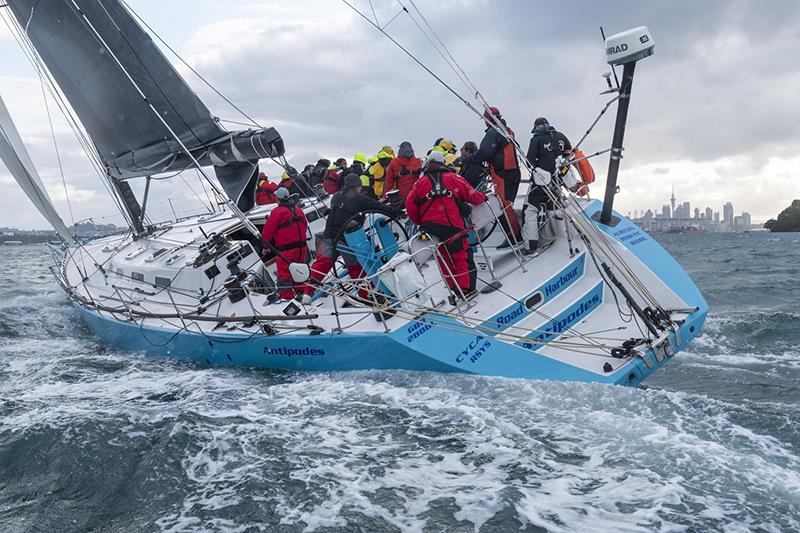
406,172,486,228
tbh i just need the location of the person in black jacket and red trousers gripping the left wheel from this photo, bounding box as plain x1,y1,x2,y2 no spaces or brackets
303,173,395,304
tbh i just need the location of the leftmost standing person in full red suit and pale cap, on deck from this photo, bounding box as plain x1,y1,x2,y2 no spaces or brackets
261,187,308,301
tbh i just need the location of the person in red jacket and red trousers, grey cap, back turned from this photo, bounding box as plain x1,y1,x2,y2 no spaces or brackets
406,151,486,294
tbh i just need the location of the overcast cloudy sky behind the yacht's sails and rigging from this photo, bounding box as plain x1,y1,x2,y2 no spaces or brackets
0,0,800,228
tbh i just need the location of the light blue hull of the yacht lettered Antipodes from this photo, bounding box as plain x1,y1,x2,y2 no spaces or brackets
73,202,708,385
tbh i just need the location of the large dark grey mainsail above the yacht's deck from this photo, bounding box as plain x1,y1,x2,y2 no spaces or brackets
7,0,284,210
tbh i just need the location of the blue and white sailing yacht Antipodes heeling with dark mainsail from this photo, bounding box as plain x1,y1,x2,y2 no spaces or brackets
0,0,708,385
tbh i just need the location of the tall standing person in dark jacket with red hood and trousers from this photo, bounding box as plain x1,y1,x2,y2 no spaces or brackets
464,107,521,248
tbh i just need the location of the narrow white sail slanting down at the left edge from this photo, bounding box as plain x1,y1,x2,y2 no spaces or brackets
0,94,74,242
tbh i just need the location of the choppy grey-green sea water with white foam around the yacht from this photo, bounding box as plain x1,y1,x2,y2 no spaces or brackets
0,234,800,532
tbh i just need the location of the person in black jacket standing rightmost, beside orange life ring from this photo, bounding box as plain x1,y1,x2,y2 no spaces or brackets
522,117,572,255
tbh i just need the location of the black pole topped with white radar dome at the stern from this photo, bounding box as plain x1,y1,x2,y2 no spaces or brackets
600,26,655,226
